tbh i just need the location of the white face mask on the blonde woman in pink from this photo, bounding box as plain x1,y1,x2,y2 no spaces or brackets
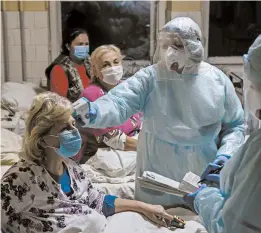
101,66,123,85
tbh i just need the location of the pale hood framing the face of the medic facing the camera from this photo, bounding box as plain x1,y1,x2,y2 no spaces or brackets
154,17,204,73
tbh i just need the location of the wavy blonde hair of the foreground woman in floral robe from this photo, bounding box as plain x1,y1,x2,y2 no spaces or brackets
20,92,72,161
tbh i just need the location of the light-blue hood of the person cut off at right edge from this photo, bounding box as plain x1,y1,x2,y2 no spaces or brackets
244,35,261,85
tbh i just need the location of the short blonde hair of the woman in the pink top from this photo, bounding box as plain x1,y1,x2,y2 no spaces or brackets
90,45,124,82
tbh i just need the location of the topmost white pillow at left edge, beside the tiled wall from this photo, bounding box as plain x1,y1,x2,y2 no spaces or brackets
1,82,36,112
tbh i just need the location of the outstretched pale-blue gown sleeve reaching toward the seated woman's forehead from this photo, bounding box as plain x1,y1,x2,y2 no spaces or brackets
89,67,154,128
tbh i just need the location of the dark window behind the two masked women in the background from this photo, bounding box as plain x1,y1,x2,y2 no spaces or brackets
62,1,150,60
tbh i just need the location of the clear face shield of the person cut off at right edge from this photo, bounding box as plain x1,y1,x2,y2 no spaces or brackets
244,87,261,135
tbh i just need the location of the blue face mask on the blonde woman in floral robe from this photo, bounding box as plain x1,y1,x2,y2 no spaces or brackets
47,129,82,158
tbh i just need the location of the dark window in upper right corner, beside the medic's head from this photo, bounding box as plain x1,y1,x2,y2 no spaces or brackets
209,1,261,57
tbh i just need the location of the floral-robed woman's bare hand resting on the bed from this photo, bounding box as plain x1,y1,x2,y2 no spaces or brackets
138,203,173,227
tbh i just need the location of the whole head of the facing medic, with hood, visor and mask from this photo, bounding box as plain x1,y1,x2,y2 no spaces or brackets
153,17,204,74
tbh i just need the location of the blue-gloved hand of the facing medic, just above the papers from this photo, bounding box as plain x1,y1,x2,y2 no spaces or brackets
200,155,228,185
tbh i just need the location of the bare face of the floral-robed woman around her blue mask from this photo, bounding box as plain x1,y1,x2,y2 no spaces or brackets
44,116,76,148
